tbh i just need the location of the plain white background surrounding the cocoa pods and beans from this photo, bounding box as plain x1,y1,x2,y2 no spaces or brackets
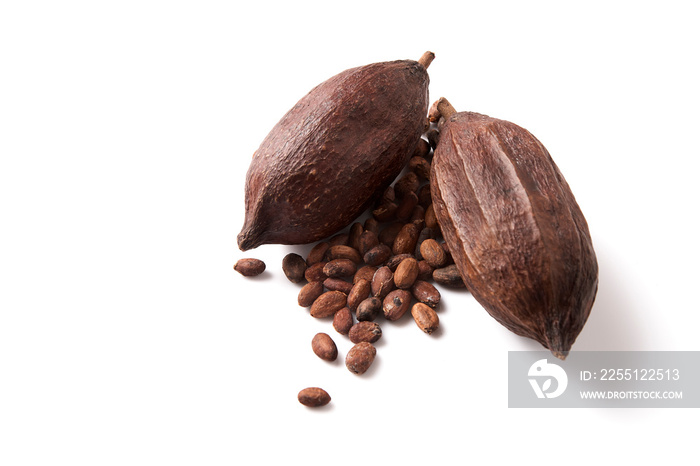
0,1,700,466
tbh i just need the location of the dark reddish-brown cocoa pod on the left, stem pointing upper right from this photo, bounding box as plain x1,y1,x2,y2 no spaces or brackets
238,52,434,251
